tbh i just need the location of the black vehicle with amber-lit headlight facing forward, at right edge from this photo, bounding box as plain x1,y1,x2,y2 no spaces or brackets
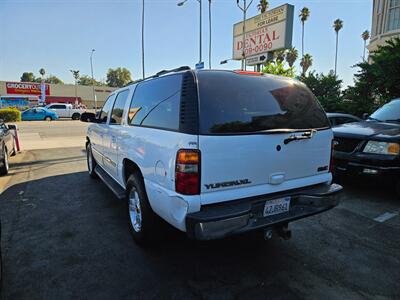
333,99,400,194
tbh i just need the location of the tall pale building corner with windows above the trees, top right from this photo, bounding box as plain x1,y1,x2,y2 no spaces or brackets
368,0,400,52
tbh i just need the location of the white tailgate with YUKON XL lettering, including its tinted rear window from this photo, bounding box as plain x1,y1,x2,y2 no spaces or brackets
198,71,333,204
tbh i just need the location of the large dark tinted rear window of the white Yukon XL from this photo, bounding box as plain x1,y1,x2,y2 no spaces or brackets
197,71,330,134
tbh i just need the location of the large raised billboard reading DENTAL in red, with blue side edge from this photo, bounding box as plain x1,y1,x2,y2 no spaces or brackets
233,4,294,65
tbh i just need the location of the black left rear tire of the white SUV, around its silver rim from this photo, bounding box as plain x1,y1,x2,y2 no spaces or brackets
125,172,162,246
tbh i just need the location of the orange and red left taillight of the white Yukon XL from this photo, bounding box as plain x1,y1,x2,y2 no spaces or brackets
175,149,200,195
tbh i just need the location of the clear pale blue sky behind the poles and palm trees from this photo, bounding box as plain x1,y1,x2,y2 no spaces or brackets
0,0,373,86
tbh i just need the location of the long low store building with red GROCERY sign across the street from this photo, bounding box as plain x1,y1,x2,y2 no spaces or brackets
0,81,116,109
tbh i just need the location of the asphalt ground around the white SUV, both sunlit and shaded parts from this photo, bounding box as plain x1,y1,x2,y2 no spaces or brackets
0,122,400,299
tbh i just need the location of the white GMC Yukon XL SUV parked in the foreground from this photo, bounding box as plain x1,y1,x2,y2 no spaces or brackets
81,67,342,242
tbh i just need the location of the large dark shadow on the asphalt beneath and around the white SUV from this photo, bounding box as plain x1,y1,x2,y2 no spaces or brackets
0,172,399,299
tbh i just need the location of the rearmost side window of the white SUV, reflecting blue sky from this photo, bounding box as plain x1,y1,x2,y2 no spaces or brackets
128,75,182,130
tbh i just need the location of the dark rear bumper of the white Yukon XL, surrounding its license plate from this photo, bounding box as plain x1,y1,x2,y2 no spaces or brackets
186,184,343,240
